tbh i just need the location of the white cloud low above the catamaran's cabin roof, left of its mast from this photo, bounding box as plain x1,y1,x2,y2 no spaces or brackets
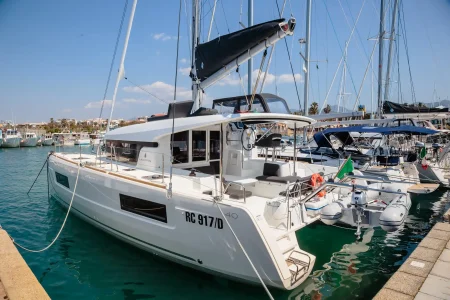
123,81,192,101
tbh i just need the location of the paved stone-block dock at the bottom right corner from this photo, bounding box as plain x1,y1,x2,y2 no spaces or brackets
374,210,450,300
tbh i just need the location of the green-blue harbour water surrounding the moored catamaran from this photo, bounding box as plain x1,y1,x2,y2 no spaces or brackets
0,147,450,300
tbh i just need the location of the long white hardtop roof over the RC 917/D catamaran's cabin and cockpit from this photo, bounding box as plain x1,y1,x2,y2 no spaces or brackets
105,113,316,142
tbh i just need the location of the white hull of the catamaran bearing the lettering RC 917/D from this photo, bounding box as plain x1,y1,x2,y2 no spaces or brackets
49,156,315,289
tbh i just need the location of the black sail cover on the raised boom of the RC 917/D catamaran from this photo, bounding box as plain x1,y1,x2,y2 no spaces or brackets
195,19,284,81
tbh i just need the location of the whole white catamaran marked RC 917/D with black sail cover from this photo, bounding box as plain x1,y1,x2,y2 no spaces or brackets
49,1,324,289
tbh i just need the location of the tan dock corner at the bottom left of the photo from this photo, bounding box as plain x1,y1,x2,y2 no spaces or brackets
0,229,50,300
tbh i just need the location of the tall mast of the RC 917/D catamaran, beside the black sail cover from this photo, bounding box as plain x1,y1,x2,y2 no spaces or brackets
191,0,201,111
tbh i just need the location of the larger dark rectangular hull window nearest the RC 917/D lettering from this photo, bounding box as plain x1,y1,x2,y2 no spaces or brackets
119,194,167,223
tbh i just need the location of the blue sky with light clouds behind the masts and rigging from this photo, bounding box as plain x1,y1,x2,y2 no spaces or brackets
0,0,450,122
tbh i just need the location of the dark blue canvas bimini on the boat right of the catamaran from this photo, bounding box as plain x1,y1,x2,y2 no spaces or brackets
314,125,439,148
